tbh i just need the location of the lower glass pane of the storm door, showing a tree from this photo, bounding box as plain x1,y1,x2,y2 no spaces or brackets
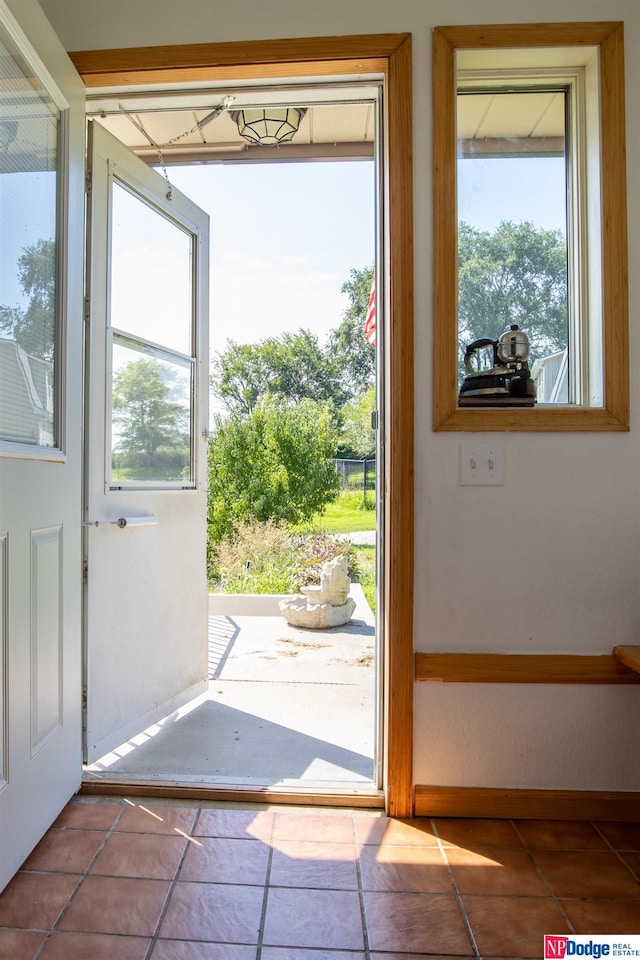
111,337,193,485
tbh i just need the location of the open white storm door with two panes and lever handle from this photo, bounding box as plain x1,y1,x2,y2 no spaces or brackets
84,122,208,761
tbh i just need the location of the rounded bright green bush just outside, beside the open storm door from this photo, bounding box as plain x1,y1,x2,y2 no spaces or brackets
208,396,339,544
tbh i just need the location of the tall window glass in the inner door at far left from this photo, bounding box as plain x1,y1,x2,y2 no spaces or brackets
0,21,60,447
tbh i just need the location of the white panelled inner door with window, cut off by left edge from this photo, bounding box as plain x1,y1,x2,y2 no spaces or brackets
0,0,84,889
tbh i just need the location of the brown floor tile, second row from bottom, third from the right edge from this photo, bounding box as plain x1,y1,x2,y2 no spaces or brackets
364,893,472,956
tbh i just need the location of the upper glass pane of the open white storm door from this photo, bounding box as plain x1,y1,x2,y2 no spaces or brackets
111,183,193,355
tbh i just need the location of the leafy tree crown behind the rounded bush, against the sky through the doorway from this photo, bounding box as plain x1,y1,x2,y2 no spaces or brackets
211,329,345,414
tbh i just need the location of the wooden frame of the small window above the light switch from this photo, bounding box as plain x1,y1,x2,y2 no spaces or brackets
432,22,629,431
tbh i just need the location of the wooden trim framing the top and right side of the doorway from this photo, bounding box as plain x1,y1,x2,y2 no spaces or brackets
70,34,414,817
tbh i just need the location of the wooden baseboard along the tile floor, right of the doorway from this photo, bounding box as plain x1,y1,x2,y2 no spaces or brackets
414,786,640,821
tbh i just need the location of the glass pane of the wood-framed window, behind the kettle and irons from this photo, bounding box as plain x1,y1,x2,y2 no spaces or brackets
457,89,570,403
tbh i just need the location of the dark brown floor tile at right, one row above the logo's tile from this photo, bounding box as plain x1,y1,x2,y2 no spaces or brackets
533,850,640,900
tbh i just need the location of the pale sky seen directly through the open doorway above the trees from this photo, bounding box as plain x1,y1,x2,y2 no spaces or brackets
168,161,375,352
